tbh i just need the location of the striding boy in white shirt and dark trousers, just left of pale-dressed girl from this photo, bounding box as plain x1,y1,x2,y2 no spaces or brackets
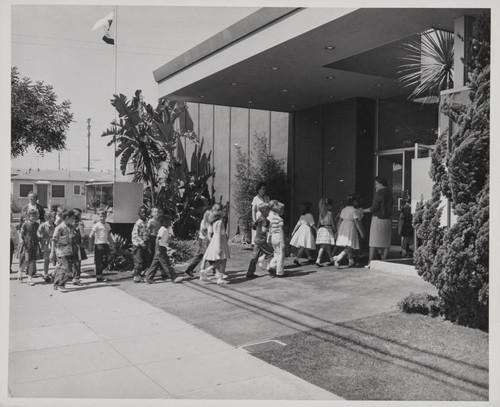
146,216,183,284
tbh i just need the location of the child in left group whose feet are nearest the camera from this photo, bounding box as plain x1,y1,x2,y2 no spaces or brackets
50,210,75,292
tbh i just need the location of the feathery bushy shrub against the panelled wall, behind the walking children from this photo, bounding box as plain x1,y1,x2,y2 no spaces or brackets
234,133,288,242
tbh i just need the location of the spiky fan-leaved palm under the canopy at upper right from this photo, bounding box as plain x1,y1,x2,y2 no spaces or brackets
398,30,454,102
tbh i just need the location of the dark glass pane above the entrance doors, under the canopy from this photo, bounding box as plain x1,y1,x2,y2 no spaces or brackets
378,100,438,151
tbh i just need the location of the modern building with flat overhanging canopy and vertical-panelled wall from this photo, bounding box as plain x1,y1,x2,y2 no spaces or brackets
154,8,482,244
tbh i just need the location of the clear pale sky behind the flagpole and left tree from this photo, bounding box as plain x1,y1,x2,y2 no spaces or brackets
10,4,257,171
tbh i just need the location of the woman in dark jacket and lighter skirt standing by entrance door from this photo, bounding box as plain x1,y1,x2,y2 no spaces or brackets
363,177,393,268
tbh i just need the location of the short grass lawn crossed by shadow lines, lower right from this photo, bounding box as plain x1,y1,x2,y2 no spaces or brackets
253,311,488,400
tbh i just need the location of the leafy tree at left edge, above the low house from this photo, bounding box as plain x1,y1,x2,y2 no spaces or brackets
10,67,73,158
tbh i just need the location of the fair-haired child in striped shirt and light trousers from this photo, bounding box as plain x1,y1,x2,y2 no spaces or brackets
267,200,286,277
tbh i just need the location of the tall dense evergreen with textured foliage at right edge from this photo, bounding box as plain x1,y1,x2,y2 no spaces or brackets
414,14,490,329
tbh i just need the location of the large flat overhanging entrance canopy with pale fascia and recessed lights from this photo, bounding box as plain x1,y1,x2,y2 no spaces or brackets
154,8,479,112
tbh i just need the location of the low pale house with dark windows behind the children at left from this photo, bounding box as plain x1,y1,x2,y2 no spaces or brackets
11,169,113,211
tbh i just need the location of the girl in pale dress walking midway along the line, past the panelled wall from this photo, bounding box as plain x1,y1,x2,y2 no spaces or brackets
200,209,231,285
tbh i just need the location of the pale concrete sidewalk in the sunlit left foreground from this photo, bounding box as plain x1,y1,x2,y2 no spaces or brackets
8,274,340,400
